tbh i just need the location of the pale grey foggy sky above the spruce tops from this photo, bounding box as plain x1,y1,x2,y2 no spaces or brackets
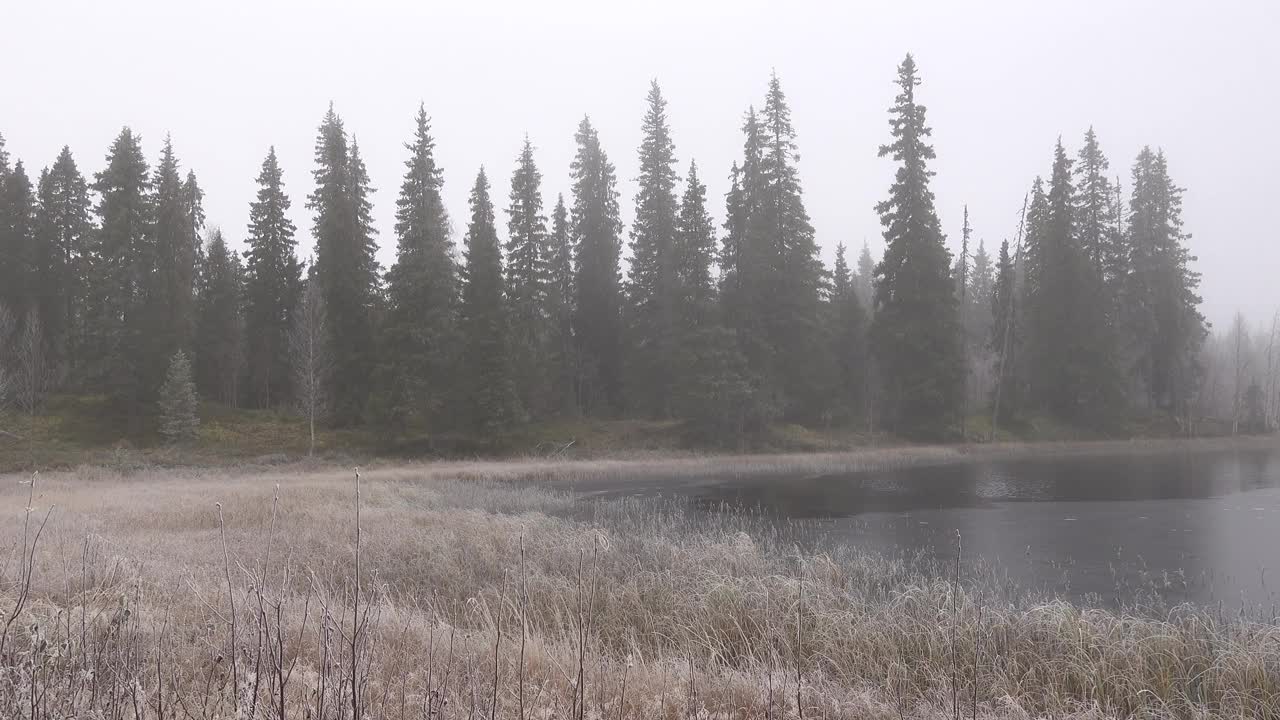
0,0,1280,329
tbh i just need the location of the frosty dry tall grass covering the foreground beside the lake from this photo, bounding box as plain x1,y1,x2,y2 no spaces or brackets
0,464,1280,720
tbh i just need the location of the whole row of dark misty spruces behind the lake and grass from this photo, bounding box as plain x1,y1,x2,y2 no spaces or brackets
0,55,1207,445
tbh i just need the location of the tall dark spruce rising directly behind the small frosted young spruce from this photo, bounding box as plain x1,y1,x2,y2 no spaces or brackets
146,137,202,388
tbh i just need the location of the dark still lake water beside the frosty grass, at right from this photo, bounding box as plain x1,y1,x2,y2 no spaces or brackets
586,448,1280,607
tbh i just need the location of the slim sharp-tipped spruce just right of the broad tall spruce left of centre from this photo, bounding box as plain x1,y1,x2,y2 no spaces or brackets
461,168,521,432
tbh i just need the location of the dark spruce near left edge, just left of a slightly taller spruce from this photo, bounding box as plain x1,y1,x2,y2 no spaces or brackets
36,146,93,371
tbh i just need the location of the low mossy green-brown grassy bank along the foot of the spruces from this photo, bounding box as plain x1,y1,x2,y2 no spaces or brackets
0,396,1267,471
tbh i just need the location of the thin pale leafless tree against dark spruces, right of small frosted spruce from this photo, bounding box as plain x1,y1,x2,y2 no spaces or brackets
289,278,333,456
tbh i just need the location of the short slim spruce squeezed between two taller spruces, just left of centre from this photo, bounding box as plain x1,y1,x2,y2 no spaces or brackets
544,195,579,413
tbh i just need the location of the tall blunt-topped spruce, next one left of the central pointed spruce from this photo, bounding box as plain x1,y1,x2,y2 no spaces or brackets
570,118,622,415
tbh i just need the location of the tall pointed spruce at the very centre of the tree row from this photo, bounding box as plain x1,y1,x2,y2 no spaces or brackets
627,81,680,418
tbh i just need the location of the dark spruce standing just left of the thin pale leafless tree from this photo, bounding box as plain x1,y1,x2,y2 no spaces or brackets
240,146,302,407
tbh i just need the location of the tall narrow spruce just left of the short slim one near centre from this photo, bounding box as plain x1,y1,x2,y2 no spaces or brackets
507,136,554,416
